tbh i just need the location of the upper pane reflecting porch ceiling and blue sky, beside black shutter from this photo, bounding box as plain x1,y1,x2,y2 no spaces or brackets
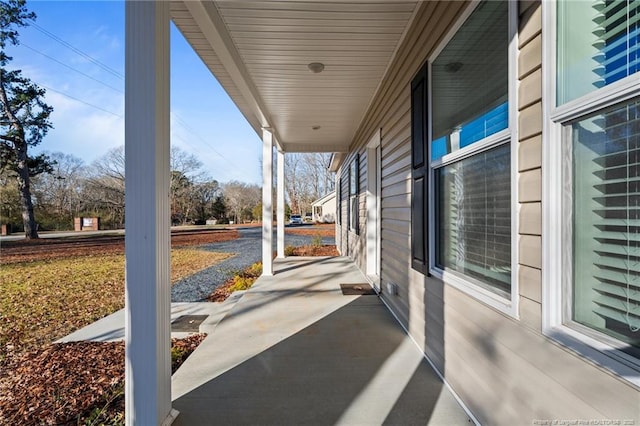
431,1,509,160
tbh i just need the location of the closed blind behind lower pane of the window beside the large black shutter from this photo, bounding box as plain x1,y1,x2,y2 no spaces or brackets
436,144,511,296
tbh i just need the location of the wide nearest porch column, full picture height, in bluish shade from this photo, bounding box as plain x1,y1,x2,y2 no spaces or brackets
125,0,177,425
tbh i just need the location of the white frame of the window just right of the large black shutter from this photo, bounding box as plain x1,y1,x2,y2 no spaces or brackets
428,0,520,319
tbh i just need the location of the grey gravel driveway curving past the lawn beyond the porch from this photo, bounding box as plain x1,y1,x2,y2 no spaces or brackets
171,228,335,302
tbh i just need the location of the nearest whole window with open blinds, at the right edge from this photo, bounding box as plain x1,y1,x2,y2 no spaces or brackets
544,0,640,384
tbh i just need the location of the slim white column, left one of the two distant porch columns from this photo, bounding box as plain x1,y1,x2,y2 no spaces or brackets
262,129,273,275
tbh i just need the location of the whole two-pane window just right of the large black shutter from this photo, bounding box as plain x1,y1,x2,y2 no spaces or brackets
420,1,517,313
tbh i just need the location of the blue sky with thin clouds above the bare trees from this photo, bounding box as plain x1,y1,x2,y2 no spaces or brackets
7,1,261,183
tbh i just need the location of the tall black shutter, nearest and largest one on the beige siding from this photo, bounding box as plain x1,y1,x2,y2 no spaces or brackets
411,64,429,275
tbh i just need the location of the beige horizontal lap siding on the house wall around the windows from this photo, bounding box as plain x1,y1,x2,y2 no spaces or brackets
338,1,640,425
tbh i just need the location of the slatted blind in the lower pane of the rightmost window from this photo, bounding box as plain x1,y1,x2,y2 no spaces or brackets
573,100,640,347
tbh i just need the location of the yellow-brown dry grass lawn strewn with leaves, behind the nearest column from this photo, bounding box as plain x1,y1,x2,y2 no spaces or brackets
0,248,230,363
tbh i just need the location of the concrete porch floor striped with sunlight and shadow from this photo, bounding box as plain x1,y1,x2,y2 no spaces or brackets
172,257,473,426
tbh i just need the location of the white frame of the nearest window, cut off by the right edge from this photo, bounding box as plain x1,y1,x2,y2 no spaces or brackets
542,1,640,386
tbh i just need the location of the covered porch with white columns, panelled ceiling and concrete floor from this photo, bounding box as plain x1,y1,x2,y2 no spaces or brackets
125,1,436,425
